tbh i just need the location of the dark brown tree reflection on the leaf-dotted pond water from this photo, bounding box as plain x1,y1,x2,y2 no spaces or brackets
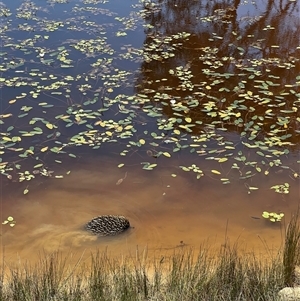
136,1,300,141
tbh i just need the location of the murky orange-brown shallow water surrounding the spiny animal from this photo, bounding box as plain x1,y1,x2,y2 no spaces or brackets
1,155,299,263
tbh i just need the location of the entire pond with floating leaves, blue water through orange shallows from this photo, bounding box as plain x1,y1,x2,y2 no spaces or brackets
0,0,300,262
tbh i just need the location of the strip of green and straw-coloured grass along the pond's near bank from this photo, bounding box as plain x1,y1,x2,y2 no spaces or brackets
0,214,300,301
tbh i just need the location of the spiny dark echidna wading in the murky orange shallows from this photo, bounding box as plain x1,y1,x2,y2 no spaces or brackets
85,215,130,236
